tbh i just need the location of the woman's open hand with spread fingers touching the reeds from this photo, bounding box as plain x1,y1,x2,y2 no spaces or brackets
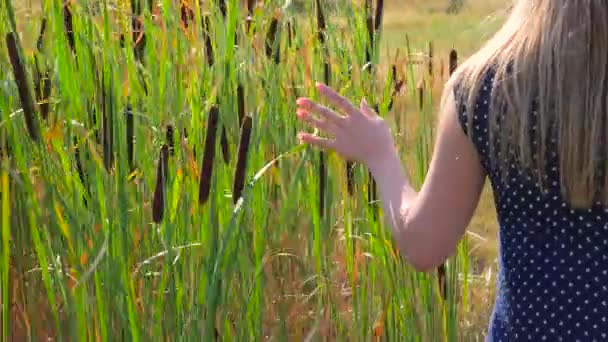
297,84,396,168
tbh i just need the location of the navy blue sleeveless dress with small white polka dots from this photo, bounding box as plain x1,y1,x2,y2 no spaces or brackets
455,68,608,342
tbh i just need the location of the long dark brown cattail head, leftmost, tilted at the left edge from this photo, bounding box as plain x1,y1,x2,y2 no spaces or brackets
6,32,40,141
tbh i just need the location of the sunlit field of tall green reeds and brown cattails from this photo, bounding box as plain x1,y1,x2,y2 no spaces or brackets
0,0,507,341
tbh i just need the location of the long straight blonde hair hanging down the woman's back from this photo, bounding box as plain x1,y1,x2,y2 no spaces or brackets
443,0,608,208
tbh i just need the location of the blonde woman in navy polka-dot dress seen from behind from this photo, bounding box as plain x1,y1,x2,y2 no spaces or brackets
297,0,608,341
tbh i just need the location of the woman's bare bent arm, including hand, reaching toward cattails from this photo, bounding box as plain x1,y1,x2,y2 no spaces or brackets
298,85,485,271
